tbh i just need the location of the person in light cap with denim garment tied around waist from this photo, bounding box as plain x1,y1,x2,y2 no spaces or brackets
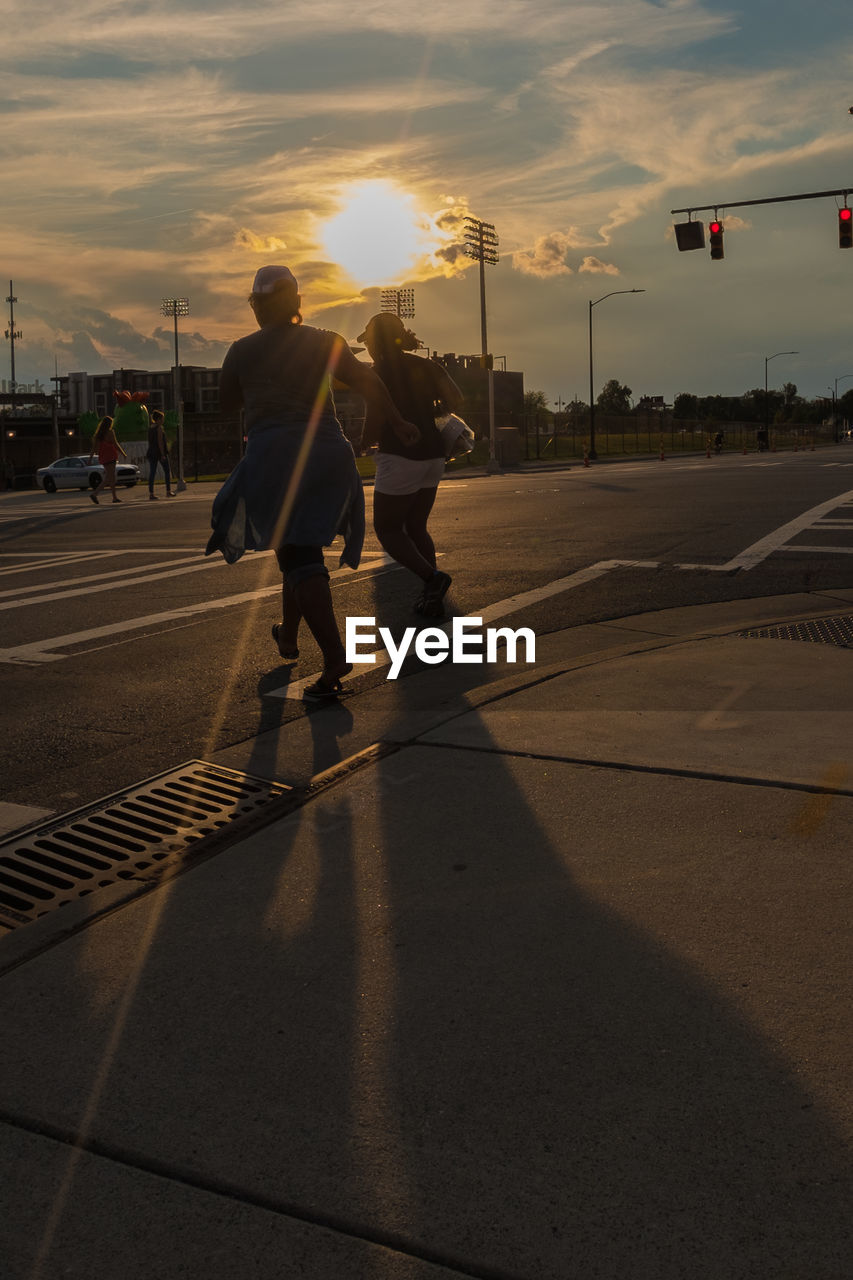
206,266,418,701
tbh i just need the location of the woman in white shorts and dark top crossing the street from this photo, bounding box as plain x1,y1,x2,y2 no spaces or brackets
357,311,462,618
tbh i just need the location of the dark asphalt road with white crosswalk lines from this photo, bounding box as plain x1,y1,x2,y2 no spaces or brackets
0,444,853,812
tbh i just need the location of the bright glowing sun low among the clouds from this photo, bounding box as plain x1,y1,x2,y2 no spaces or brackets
320,182,429,288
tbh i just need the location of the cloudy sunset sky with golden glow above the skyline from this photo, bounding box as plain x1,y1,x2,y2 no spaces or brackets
0,0,853,403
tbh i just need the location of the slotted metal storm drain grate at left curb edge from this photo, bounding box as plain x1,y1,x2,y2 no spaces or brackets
0,760,292,929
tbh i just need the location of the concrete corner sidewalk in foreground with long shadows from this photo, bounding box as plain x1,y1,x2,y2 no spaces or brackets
0,591,853,1280
